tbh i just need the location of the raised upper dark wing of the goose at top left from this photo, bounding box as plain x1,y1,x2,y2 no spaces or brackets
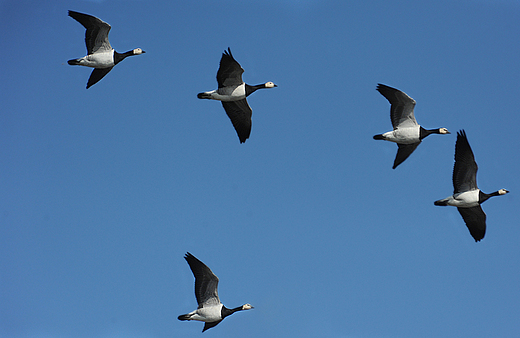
69,11,112,55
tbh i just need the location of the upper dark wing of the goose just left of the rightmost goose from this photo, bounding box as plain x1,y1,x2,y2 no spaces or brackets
377,83,417,129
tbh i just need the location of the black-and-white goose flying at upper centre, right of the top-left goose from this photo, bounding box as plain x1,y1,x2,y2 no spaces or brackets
197,47,278,143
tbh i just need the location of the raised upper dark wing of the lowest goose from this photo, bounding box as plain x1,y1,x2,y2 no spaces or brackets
184,252,220,306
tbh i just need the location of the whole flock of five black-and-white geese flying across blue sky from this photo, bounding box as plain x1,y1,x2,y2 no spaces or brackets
68,11,509,332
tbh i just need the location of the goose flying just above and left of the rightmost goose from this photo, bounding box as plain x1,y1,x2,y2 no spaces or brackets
374,83,451,169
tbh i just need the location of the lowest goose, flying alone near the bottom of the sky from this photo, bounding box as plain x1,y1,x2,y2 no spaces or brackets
178,252,253,332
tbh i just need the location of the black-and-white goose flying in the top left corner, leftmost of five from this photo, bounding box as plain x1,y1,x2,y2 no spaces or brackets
67,11,146,89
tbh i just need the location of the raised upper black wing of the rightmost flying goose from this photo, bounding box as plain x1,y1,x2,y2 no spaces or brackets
453,130,478,194
